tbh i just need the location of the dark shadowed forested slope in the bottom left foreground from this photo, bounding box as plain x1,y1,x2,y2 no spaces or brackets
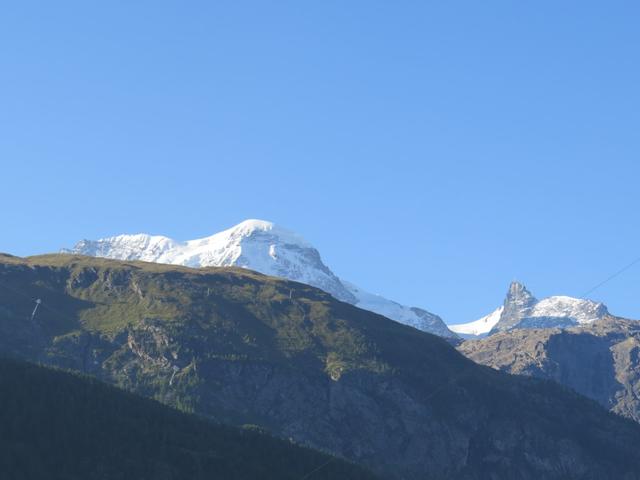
0,359,374,480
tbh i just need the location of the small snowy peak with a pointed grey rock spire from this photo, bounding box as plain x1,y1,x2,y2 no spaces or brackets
449,281,609,338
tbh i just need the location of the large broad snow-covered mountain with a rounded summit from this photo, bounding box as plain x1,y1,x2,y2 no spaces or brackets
63,220,456,338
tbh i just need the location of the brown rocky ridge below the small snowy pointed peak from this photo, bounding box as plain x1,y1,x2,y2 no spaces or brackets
459,316,640,421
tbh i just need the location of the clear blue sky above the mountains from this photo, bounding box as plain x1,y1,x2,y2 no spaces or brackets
0,0,640,323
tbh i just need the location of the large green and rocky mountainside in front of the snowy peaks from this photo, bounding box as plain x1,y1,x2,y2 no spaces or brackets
0,255,640,480
